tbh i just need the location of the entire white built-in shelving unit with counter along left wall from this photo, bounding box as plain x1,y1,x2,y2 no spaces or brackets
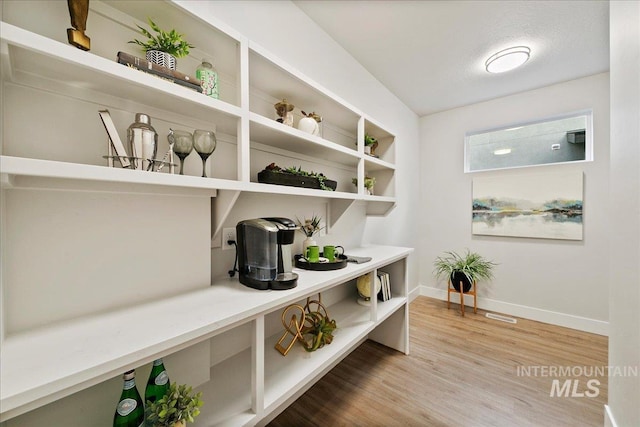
0,0,411,426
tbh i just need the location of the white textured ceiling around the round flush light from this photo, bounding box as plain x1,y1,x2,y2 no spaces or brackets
294,0,609,116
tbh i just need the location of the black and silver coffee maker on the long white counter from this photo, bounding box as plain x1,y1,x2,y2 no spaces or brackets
236,218,298,290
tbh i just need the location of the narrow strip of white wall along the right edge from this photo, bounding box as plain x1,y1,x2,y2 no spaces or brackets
605,1,640,427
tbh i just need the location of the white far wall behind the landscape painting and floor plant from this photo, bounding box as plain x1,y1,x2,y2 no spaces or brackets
419,73,609,333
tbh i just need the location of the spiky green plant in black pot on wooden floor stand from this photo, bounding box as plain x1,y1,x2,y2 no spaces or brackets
433,249,496,292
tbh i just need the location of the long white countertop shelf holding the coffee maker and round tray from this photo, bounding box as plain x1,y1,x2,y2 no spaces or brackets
0,246,412,419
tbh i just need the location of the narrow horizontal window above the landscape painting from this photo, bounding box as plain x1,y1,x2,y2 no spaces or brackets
464,110,593,172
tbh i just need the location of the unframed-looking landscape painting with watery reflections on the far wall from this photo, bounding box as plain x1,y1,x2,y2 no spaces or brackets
471,172,583,240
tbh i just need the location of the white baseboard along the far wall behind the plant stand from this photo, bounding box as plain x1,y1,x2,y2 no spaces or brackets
419,285,609,336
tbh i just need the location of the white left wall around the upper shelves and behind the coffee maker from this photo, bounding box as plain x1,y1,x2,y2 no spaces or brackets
178,1,420,288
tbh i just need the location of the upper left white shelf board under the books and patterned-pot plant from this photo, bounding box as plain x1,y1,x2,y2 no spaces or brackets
0,22,242,135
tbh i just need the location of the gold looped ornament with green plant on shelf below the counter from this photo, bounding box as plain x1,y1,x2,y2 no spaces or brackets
275,294,337,356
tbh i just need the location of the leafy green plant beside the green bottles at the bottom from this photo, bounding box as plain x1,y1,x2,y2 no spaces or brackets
146,382,203,427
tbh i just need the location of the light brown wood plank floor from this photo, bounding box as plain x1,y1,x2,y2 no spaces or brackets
269,297,608,427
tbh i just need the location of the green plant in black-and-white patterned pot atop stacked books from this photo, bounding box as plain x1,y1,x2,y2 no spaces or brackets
129,18,194,70
